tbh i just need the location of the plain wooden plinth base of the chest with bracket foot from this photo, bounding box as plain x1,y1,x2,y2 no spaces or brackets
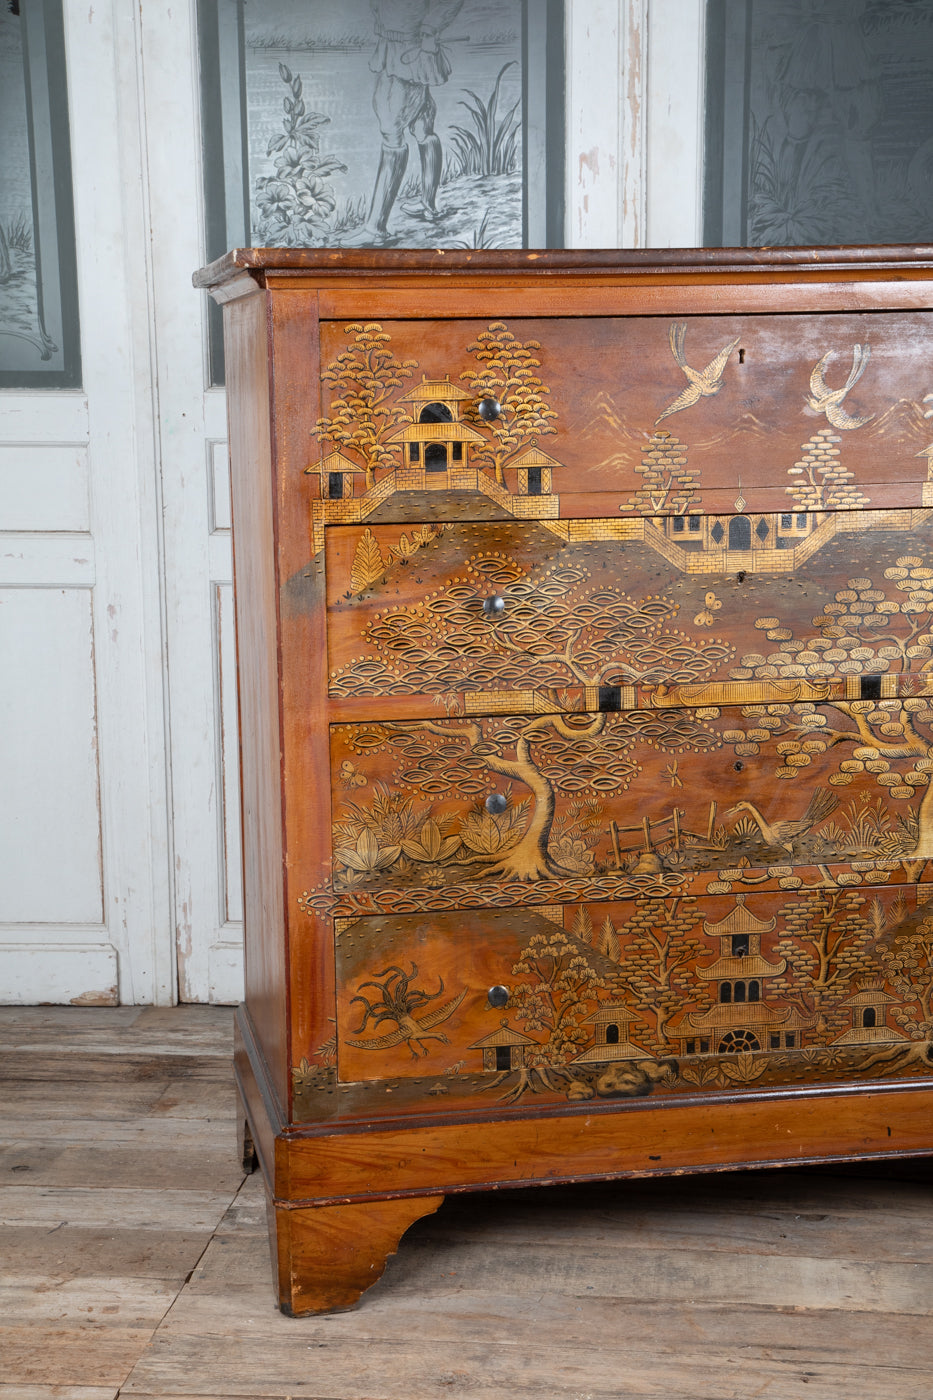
237,1008,933,1316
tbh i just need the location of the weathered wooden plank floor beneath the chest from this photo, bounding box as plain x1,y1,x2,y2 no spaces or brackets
0,1007,933,1400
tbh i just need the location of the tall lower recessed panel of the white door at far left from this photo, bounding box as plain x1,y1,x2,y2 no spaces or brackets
0,588,104,924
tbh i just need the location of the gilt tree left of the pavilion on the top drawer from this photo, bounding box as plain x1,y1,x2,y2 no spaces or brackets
315,321,417,491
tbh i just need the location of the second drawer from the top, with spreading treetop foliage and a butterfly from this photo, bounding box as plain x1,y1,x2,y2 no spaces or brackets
326,507,933,714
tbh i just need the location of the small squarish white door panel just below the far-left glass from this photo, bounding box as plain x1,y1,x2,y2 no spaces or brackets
0,442,91,532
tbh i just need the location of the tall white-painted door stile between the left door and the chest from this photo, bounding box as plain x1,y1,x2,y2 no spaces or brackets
140,0,242,1002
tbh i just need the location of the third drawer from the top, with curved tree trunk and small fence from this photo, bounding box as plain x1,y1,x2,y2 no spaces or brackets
331,699,933,907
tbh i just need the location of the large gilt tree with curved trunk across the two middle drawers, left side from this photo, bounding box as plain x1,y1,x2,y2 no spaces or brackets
332,554,733,881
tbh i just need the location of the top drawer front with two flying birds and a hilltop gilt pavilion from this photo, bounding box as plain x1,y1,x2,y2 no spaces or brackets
310,312,933,521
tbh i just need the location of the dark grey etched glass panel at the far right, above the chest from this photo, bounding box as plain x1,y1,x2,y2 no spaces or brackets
705,0,933,246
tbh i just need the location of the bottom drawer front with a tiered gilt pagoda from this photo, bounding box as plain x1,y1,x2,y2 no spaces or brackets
294,886,933,1117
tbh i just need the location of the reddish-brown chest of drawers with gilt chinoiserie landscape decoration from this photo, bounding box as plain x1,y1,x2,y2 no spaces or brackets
196,249,933,1313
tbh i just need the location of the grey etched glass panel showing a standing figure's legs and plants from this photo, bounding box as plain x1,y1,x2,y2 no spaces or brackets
199,0,565,382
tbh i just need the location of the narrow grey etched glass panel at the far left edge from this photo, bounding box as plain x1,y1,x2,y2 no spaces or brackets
0,0,81,388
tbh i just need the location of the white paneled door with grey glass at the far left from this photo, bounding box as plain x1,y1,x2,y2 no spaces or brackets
0,0,175,1005
